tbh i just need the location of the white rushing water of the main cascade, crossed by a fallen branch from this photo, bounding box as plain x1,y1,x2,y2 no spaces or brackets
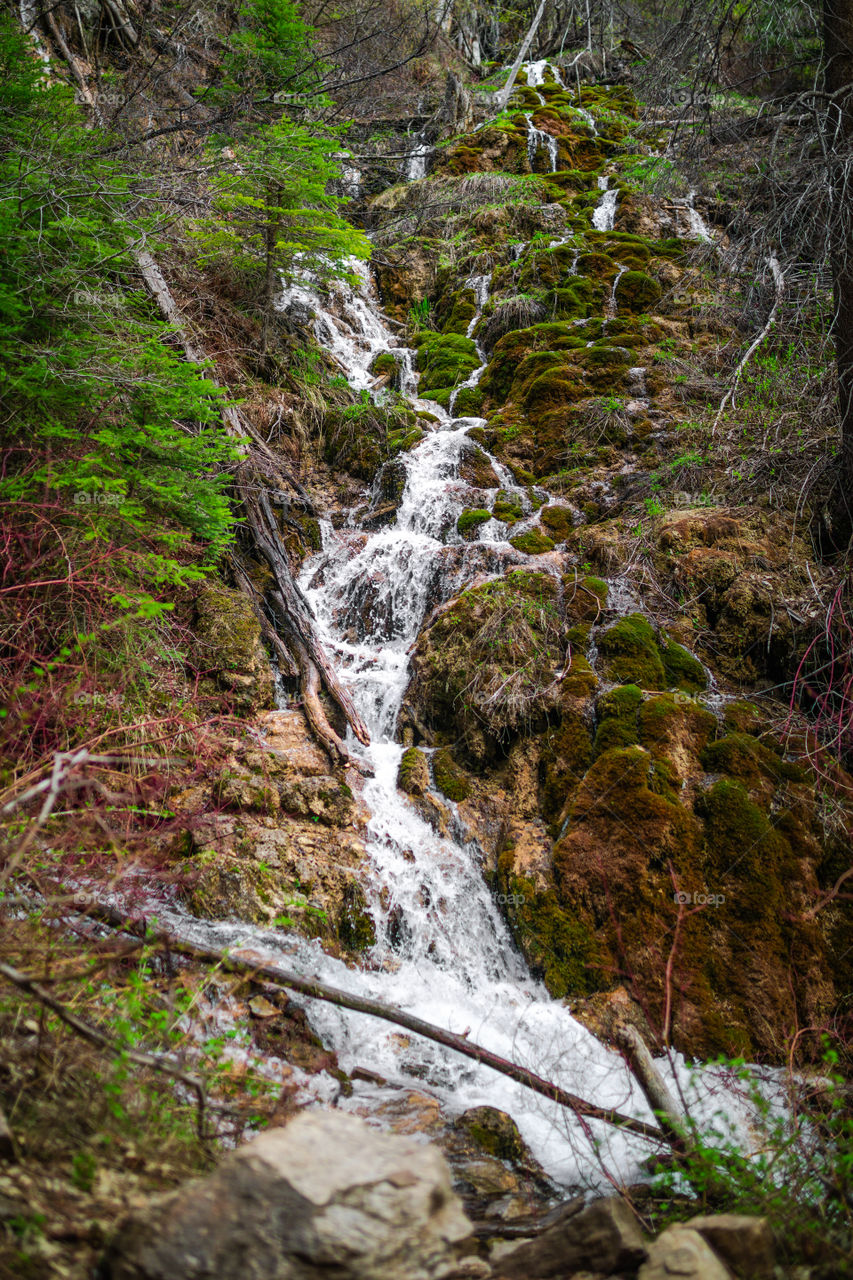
240,259,783,1187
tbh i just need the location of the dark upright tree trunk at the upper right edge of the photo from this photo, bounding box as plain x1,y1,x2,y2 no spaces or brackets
824,0,853,550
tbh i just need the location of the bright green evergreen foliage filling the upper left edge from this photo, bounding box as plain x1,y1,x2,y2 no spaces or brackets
0,18,237,611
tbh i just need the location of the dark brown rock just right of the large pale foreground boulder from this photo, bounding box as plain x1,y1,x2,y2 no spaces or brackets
491,1198,646,1280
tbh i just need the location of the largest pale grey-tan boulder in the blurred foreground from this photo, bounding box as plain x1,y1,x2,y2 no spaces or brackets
101,1111,471,1280
